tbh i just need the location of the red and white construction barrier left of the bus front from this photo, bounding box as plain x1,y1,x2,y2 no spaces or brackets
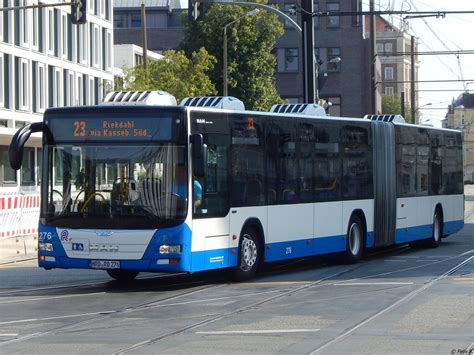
0,192,40,238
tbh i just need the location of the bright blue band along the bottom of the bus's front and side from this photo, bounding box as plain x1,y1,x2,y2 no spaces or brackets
38,220,464,272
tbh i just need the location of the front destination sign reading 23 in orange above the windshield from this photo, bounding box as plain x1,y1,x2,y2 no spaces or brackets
46,115,180,142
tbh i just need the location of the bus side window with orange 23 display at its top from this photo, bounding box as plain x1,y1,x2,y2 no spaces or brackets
231,116,266,207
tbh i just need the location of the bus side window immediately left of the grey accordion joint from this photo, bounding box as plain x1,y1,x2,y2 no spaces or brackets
341,125,373,200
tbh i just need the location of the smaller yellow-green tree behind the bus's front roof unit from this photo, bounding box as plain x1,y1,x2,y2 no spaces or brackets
118,48,217,102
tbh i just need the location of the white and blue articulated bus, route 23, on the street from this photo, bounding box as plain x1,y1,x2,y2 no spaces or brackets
9,92,464,280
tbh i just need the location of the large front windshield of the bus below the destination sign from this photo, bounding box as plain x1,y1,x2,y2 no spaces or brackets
41,143,188,229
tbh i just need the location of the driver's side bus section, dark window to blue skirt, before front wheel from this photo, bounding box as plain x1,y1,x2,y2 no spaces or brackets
190,111,233,271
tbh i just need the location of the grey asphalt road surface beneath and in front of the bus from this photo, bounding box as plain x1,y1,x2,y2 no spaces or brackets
0,201,474,354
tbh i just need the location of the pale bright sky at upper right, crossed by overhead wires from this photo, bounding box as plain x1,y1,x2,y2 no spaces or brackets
364,0,474,127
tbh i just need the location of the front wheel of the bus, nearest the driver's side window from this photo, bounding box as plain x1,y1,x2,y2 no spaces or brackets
231,227,262,281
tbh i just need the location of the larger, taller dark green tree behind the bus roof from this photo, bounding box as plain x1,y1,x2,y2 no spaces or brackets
181,4,283,110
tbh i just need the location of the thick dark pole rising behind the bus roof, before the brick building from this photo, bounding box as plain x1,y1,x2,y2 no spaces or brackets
301,0,319,103
